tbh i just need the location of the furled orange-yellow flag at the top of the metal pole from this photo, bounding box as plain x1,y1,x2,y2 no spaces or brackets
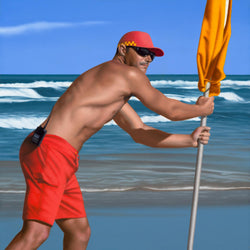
197,0,232,96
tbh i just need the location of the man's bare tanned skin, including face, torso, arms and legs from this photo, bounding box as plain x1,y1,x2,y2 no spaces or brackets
6,45,214,250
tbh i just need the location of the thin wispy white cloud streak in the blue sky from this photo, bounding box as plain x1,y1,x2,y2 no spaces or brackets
0,21,107,36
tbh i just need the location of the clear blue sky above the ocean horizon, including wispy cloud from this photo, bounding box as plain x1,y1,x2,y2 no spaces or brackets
0,0,250,74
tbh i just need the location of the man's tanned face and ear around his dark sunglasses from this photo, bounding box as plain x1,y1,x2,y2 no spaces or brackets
125,47,152,74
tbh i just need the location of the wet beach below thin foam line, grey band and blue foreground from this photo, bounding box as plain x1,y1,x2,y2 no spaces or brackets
0,161,250,250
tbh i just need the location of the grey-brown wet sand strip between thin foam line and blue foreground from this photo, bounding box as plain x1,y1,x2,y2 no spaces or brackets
0,190,250,218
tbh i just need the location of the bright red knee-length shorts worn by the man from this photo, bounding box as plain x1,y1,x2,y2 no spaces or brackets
20,133,86,225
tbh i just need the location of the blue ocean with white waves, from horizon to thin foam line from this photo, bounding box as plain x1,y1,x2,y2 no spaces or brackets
0,75,250,200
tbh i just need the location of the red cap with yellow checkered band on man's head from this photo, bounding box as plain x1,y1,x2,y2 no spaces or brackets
118,31,164,56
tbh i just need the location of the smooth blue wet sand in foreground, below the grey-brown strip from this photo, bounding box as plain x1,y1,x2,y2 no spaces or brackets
0,200,250,250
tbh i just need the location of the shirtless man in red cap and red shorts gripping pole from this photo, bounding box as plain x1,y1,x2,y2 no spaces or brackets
7,31,214,250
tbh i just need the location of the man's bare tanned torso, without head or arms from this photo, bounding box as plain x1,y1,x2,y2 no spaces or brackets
44,60,145,151
